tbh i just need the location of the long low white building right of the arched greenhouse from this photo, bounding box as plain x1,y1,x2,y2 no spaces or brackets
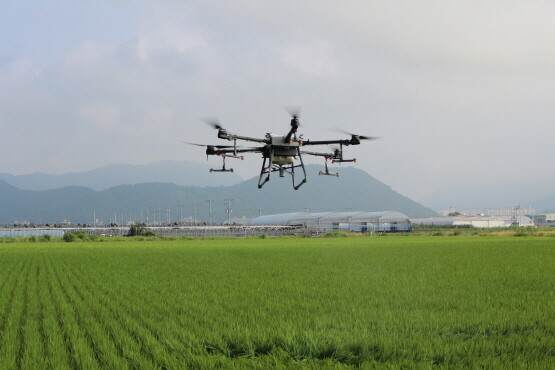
410,215,534,227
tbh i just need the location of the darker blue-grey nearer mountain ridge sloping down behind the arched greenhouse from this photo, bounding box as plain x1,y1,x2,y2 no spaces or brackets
0,165,436,224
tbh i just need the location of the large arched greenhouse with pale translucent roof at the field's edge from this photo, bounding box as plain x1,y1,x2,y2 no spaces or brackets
247,211,412,232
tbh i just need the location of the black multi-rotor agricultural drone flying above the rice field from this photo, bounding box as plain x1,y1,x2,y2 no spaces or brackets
186,112,377,190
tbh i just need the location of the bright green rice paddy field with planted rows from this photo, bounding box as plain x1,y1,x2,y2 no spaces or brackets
0,236,555,369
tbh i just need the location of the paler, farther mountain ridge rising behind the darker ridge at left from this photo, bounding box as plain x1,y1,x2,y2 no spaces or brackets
0,161,243,190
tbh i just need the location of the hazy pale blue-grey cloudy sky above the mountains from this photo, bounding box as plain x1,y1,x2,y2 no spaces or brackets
0,0,555,208
